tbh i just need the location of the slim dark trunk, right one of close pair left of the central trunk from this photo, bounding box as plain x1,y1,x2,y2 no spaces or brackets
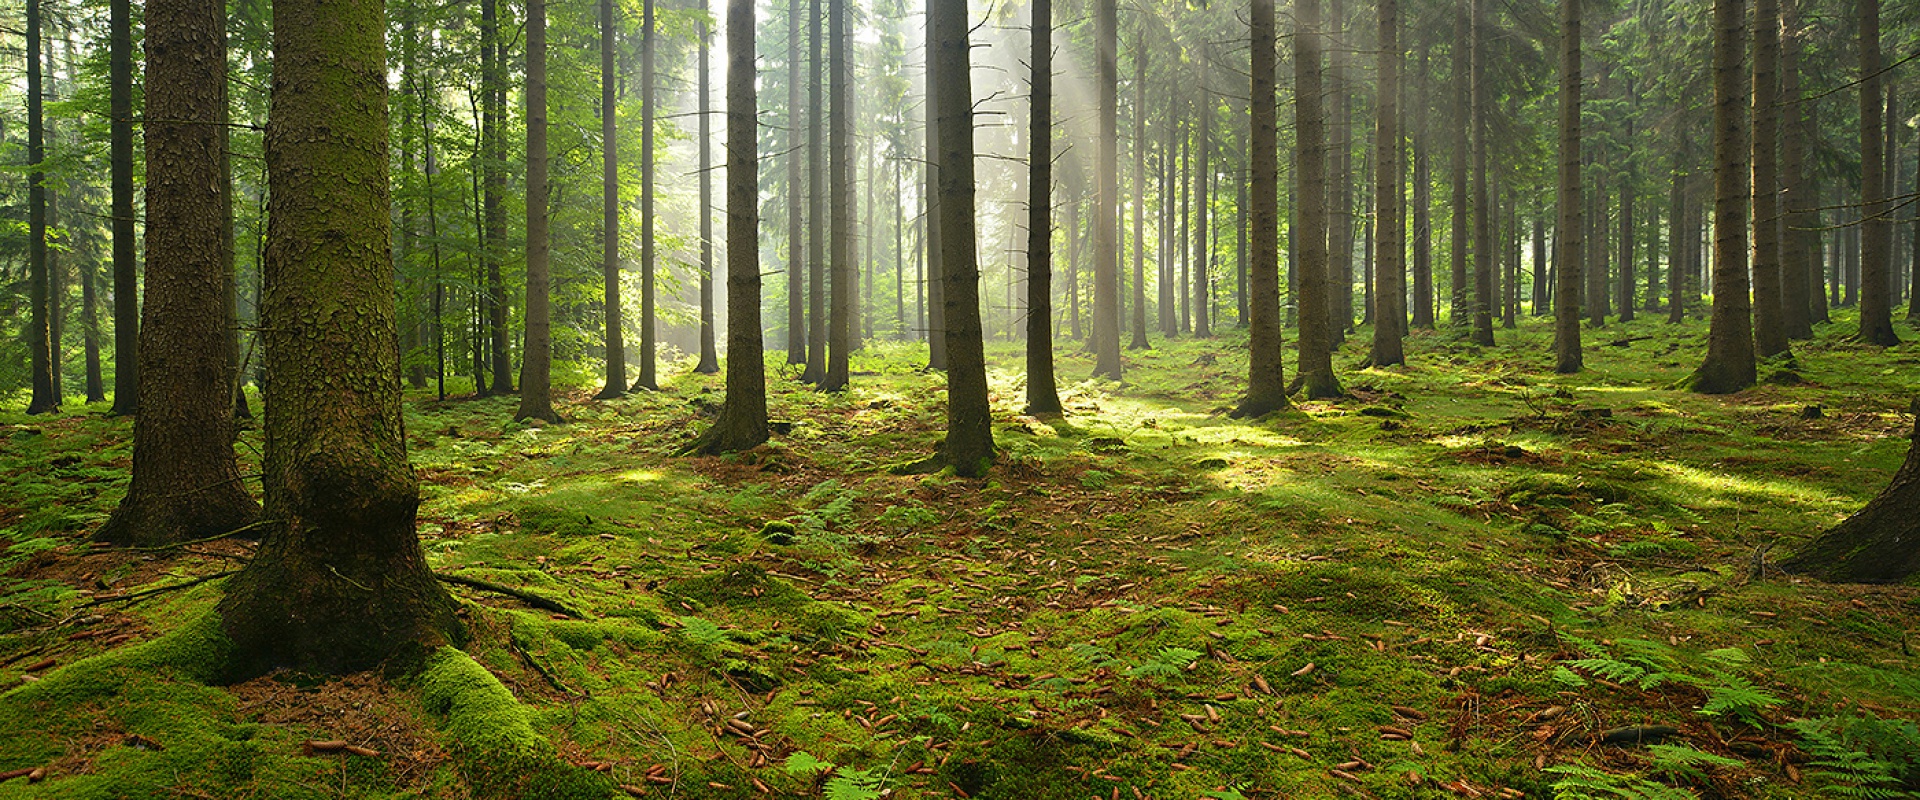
820,0,854,391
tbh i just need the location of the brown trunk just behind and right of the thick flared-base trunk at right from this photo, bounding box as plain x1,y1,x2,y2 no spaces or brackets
1751,0,1788,359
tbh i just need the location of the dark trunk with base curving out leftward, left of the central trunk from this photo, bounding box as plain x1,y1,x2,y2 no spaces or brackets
687,0,764,455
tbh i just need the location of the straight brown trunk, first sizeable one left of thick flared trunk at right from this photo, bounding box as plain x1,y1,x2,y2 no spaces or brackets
1553,0,1586,374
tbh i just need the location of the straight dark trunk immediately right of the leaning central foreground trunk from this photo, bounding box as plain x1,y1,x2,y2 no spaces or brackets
1027,0,1062,414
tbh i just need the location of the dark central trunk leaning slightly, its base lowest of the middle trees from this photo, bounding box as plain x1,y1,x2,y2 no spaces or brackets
929,0,998,478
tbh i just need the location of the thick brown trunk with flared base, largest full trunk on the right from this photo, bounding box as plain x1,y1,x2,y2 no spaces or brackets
1692,0,1758,395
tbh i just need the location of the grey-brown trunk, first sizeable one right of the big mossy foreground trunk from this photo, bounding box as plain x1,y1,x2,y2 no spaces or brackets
518,0,560,422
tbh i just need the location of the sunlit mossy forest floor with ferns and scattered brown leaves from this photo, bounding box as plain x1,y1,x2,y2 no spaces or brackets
0,308,1920,800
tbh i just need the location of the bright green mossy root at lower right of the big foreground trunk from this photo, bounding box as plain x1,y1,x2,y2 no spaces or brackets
420,647,614,800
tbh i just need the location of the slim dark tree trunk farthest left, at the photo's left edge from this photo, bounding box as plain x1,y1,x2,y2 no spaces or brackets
27,0,60,414
